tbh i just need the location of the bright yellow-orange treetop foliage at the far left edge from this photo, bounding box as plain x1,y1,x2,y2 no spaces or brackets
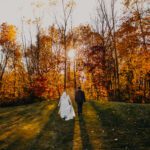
0,23,16,45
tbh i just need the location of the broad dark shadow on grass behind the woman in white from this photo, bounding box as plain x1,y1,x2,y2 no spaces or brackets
30,108,74,150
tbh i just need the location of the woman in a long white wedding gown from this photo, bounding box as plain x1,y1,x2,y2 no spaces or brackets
58,92,75,121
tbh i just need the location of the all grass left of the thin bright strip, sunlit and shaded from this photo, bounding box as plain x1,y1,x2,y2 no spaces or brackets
0,102,74,150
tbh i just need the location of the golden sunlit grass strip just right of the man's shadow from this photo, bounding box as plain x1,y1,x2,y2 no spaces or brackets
80,102,103,150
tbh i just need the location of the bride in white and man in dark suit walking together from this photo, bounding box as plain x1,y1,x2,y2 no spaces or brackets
58,87,85,121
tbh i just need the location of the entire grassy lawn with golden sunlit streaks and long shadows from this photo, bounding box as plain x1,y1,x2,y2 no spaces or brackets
0,101,150,150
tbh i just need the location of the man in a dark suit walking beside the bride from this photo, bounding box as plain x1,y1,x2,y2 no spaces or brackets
75,87,86,116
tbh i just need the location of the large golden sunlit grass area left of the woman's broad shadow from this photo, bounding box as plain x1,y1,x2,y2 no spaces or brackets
0,102,57,150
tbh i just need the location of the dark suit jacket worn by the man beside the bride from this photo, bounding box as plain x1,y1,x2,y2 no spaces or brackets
75,90,85,103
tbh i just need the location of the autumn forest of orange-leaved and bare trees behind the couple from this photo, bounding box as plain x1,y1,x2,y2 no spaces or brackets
0,0,150,106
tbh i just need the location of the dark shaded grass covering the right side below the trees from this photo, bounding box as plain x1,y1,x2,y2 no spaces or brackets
88,102,150,150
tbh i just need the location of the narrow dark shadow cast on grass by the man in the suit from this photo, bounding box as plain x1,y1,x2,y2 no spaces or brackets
79,115,92,150
